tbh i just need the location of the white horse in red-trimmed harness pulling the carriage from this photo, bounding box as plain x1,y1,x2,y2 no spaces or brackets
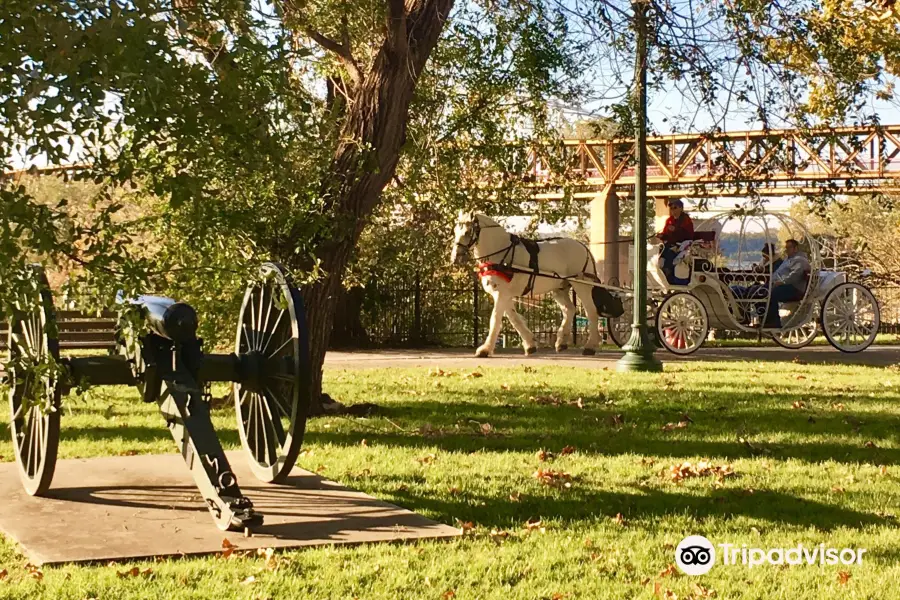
450,213,600,357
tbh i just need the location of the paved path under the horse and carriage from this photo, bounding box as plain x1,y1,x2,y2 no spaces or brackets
325,346,900,369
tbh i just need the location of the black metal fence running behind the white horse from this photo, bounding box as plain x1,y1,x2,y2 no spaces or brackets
361,278,900,347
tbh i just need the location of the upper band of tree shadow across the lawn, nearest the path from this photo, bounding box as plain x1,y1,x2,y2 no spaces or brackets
306,400,900,465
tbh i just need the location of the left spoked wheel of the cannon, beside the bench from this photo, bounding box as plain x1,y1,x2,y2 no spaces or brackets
7,271,61,496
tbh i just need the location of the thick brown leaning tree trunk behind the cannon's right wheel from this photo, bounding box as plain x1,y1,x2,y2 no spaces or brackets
302,0,453,414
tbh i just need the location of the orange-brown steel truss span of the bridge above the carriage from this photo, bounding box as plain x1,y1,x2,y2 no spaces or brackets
527,125,900,200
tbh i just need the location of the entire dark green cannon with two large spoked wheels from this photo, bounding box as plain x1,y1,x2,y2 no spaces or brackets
5,263,311,531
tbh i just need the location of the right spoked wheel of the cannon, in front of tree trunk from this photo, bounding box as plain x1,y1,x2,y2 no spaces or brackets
233,263,310,482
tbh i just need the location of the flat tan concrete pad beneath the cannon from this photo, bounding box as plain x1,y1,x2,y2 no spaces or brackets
0,452,460,565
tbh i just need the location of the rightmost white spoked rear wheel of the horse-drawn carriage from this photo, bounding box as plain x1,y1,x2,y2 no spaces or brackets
822,283,881,353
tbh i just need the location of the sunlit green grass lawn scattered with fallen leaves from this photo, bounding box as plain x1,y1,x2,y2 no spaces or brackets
0,361,900,600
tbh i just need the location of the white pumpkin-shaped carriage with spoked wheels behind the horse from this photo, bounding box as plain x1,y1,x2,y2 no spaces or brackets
609,210,880,355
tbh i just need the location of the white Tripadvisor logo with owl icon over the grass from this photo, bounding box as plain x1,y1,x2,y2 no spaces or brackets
675,535,866,575
